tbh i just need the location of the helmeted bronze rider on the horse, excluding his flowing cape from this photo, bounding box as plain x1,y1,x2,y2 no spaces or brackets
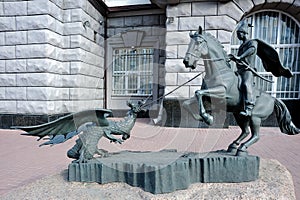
229,22,258,116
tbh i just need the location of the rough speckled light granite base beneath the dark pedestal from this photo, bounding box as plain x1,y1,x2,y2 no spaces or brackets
1,159,296,200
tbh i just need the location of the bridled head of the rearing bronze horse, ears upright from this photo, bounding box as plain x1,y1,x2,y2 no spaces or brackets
183,26,208,69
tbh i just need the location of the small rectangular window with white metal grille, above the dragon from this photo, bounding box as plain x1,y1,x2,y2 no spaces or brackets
112,48,154,96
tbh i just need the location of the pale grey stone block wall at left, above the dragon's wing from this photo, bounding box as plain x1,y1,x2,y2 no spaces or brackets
0,0,104,115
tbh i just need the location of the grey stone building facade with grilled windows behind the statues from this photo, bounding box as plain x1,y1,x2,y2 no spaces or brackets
0,0,300,128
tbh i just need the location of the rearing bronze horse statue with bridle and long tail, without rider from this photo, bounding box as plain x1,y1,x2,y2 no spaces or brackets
183,27,300,156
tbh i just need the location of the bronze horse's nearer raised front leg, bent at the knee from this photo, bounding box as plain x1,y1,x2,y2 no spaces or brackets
195,86,226,125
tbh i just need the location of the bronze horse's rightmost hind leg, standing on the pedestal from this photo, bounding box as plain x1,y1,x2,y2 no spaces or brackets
236,116,261,156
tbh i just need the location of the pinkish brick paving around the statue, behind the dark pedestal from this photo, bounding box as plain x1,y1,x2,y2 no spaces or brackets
0,119,300,199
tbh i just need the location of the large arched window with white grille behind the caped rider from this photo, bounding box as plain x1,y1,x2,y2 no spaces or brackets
231,11,300,99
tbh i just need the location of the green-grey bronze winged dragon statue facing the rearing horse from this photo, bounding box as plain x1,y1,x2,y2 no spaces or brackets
13,101,145,163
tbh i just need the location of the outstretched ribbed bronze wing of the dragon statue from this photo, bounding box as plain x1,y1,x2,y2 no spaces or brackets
12,109,111,146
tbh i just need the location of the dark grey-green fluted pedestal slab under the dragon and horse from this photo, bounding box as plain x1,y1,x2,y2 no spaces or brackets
69,150,259,194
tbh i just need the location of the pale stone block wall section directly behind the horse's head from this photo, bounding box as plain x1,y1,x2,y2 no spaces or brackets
166,1,243,99
